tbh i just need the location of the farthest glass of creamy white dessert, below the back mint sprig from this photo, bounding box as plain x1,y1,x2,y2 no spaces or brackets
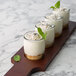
53,8,70,28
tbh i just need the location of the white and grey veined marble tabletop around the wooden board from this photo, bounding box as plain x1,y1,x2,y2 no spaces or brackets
0,0,76,76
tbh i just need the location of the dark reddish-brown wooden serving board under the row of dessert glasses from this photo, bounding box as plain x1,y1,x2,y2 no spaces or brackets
5,21,76,76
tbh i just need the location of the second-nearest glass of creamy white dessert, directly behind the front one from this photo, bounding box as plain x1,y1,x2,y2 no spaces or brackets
35,23,55,48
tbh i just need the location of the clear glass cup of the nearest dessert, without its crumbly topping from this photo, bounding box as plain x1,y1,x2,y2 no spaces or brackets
24,31,45,60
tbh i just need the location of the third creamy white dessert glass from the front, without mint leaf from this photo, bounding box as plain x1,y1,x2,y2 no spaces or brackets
42,14,63,37
